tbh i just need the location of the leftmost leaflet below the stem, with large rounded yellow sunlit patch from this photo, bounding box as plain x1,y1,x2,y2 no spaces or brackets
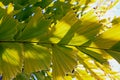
0,43,23,80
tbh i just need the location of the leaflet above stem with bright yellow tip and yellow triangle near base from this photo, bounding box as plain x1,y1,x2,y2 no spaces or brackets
58,10,101,45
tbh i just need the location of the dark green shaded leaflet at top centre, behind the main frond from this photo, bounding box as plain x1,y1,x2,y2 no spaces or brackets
49,0,71,20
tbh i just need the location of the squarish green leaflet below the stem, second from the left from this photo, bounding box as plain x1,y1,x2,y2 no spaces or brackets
23,44,51,74
